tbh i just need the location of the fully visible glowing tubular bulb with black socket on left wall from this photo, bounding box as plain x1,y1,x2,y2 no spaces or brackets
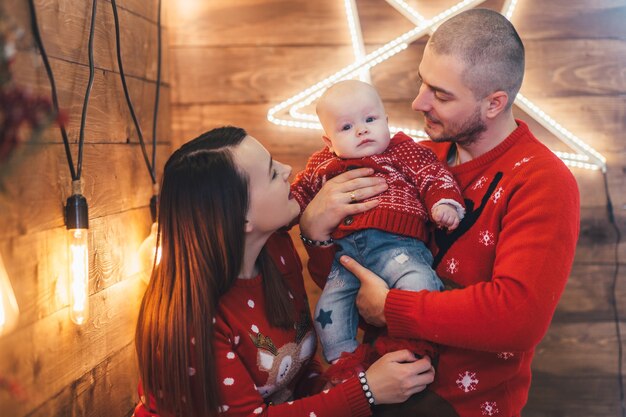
66,194,89,324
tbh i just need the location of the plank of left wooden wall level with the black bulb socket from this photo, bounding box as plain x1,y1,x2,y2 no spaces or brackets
0,144,169,239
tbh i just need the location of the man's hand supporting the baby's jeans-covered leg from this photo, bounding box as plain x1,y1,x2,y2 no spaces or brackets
340,255,389,327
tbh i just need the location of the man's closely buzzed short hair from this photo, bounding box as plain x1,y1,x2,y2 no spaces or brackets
428,9,524,109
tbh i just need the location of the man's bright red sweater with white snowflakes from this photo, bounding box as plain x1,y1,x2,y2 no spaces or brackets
307,120,580,417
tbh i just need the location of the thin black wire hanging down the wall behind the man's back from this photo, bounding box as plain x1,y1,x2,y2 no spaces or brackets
602,172,626,417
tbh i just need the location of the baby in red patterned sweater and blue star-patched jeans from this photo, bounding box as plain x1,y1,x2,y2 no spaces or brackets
291,80,465,374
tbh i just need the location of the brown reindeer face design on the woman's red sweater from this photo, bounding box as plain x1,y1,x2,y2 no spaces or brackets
249,311,317,404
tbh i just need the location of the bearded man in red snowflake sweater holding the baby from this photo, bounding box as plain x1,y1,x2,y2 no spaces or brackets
334,9,579,417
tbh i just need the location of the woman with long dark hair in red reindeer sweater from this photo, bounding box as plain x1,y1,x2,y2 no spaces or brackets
135,127,434,417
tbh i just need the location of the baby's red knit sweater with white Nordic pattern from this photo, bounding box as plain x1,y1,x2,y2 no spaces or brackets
291,132,465,242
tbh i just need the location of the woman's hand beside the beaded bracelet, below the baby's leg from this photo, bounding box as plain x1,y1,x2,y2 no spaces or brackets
365,350,435,404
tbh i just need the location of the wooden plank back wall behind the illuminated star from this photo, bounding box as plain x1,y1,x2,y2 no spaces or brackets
169,0,626,417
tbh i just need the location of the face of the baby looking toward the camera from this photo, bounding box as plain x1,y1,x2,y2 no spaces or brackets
320,91,390,158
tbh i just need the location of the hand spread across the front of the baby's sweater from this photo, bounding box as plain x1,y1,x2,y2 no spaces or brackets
300,168,387,241
